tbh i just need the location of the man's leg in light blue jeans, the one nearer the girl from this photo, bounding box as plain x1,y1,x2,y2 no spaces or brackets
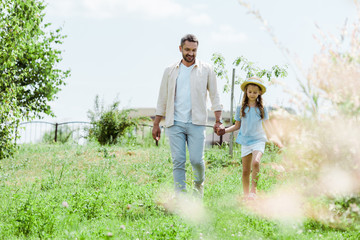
187,124,205,195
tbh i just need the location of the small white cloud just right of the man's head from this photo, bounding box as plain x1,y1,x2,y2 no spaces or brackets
211,25,248,43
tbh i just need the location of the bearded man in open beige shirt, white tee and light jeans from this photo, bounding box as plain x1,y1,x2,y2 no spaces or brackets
152,34,222,197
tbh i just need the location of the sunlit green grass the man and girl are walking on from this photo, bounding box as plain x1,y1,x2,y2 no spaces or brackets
0,144,360,240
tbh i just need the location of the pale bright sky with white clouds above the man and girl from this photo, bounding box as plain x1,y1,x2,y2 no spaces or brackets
45,0,356,122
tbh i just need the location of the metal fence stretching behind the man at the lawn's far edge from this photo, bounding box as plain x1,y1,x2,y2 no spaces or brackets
17,121,223,146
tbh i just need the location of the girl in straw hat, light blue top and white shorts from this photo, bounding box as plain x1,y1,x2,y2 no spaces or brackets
217,77,282,200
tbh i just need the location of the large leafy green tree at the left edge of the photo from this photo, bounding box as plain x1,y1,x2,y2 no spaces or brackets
0,0,70,159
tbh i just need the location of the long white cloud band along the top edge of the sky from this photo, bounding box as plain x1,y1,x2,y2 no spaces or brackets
47,0,217,26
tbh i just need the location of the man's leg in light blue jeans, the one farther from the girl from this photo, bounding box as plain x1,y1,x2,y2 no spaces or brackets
167,124,186,192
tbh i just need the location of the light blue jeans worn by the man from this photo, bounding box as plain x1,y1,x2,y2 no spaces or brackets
167,121,205,192
